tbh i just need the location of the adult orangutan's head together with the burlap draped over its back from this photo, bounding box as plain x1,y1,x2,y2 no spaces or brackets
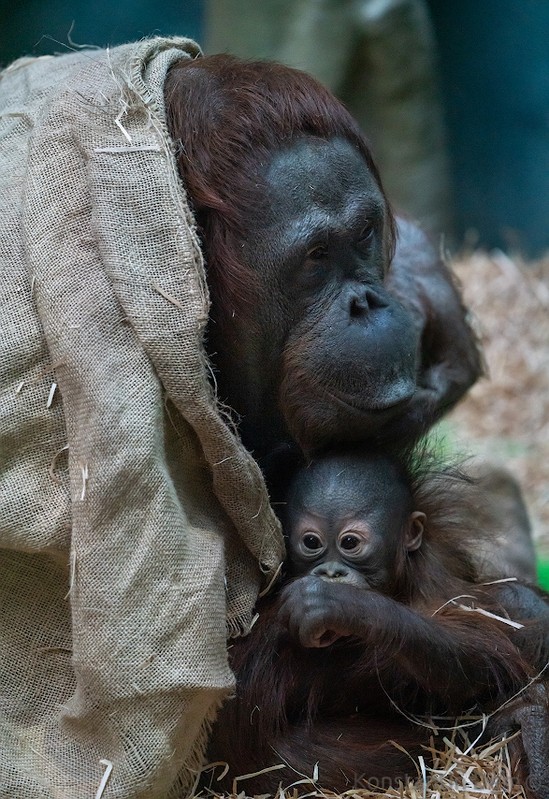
0,38,492,799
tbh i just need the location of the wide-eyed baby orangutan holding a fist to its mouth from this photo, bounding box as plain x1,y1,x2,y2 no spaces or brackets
204,452,549,799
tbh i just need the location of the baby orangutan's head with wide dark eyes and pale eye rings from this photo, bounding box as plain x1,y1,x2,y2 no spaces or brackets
285,455,425,592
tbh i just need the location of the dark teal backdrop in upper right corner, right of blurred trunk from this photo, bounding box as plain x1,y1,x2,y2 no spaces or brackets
428,0,549,253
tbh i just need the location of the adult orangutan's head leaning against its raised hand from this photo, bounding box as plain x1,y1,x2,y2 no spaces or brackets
165,55,480,462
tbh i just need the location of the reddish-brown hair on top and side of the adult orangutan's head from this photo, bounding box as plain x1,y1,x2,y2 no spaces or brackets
165,55,395,320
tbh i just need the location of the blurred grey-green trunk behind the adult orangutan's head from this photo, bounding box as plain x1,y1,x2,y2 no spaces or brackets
206,0,450,239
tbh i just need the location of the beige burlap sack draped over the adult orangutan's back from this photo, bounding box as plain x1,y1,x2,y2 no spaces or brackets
0,39,282,799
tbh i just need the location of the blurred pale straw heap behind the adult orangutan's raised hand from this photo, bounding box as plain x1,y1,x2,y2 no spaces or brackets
450,252,549,554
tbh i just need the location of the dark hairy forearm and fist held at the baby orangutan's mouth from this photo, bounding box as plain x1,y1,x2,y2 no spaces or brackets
278,575,527,706
